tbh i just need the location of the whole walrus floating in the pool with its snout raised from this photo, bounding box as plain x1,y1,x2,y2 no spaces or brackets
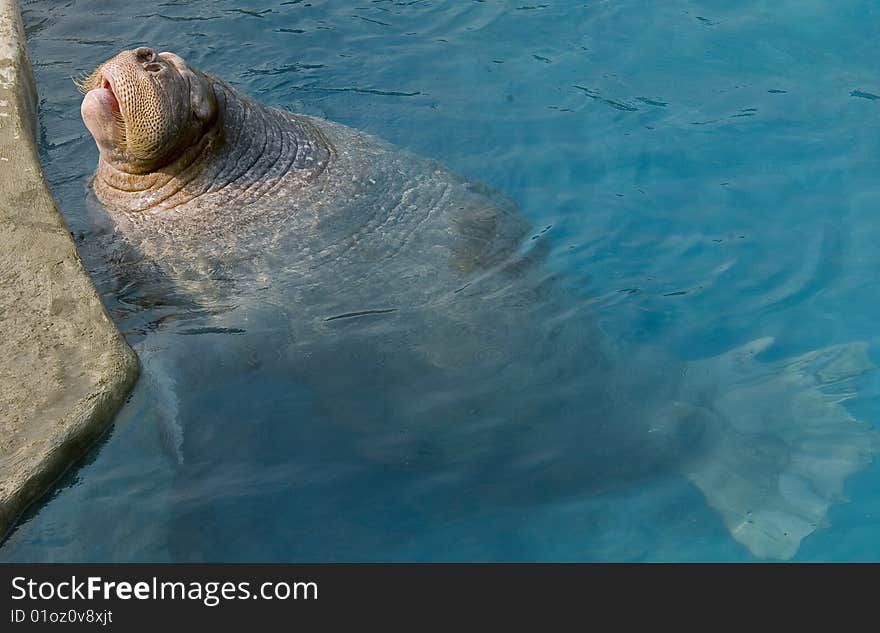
81,47,877,559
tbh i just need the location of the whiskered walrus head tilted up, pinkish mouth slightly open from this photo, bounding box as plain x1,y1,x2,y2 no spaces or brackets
78,47,217,173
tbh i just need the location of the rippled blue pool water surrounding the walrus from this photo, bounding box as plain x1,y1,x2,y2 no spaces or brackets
0,0,880,561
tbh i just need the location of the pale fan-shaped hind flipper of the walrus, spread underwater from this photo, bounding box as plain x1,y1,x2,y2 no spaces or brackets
685,339,880,559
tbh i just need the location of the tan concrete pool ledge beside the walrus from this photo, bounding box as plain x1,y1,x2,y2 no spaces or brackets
0,0,138,541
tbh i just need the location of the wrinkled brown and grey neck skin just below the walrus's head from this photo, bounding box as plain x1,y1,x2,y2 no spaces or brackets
92,77,333,212
